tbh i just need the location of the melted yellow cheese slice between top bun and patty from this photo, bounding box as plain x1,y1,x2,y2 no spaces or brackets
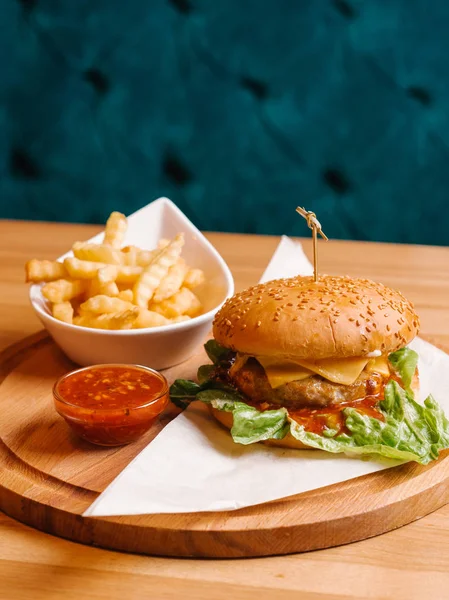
256,356,370,388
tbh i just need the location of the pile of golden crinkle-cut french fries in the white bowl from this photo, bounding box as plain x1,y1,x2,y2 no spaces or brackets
25,212,205,330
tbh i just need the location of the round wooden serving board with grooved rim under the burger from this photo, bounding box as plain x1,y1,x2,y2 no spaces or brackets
0,333,449,558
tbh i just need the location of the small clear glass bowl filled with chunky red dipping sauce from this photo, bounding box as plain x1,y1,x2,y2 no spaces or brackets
53,364,168,446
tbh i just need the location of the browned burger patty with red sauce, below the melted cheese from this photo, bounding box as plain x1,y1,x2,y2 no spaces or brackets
229,358,386,408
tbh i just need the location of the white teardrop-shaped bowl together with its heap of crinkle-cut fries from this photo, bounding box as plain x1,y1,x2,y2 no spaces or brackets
26,198,234,369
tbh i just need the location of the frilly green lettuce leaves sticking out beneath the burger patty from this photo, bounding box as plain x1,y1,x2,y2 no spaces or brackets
170,342,449,464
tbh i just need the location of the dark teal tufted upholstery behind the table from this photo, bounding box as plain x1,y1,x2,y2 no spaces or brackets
0,0,449,244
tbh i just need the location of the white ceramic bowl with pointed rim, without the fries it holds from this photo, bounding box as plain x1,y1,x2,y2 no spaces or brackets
30,198,234,369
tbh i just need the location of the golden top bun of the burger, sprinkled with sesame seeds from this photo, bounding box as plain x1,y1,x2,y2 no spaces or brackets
213,276,419,360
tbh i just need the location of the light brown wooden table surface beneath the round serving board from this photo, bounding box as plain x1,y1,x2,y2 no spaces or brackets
0,221,449,600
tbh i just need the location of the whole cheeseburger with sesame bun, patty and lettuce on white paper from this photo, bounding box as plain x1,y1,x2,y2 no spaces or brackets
171,276,449,463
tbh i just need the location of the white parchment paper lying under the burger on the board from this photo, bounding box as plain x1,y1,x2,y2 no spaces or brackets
84,237,449,517
